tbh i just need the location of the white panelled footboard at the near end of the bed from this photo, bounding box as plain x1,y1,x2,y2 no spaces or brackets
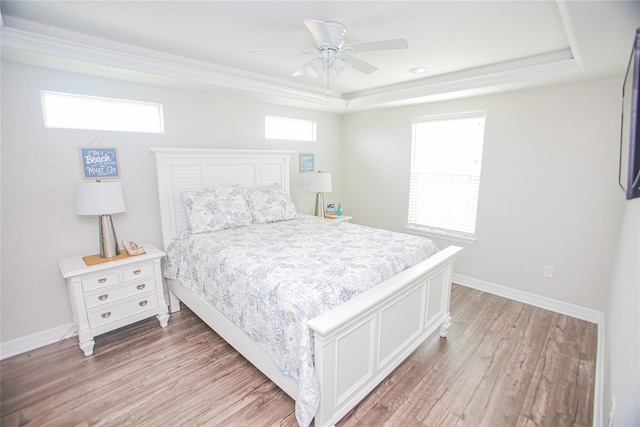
309,246,462,426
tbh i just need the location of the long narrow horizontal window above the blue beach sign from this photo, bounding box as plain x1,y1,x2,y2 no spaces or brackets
42,91,164,133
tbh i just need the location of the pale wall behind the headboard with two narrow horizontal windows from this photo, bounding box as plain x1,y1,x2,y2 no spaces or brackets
0,62,341,343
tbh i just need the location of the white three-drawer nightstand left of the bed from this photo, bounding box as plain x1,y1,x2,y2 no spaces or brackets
58,244,169,356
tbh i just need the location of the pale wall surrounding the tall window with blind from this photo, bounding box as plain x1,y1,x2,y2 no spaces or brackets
342,78,623,312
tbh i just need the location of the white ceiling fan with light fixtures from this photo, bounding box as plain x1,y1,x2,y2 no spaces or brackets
250,19,408,84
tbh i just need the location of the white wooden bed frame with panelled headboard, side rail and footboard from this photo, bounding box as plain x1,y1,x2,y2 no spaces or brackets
151,148,462,426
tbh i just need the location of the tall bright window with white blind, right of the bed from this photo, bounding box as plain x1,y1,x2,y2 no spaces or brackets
407,113,485,241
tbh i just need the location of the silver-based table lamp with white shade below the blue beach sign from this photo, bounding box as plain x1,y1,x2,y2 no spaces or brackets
76,181,125,258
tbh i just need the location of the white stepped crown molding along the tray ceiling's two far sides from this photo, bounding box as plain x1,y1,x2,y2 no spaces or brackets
2,27,582,113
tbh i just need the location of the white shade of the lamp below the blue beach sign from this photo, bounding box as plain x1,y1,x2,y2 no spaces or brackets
76,182,126,215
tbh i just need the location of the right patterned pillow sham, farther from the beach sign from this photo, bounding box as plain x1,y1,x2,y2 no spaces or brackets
244,188,299,224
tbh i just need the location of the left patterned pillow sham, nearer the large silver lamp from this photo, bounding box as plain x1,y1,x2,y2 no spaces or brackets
182,185,251,233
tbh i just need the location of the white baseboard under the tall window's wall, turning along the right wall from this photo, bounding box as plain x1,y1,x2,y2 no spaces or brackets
452,273,605,426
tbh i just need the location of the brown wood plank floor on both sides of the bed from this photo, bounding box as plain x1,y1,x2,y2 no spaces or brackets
0,285,597,427
